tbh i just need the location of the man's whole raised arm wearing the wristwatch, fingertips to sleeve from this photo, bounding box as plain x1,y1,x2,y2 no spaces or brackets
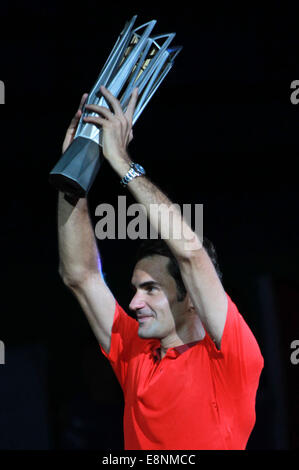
86,88,227,348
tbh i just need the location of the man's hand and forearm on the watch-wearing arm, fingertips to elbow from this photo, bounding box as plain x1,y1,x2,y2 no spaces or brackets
84,87,202,259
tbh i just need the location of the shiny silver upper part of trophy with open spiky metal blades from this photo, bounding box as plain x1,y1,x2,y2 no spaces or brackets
75,15,182,145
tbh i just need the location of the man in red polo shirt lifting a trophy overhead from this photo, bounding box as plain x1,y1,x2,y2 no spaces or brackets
58,88,263,450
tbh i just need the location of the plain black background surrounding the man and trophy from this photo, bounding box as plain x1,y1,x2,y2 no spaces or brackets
0,0,299,450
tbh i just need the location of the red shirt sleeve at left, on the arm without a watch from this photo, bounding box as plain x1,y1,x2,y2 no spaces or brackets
100,302,138,388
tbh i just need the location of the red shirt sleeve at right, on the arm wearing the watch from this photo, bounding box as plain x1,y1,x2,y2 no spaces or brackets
210,294,264,393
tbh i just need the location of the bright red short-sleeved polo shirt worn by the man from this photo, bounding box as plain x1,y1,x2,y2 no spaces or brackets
101,295,264,450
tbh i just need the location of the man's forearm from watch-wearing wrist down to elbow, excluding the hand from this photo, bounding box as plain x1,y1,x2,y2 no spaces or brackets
112,156,202,260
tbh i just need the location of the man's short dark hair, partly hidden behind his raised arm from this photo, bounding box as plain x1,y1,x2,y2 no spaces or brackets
135,237,222,301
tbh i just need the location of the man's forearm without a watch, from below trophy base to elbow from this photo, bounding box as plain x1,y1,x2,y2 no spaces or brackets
58,192,100,284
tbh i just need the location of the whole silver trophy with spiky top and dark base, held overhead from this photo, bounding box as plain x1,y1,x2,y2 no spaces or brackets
49,15,182,197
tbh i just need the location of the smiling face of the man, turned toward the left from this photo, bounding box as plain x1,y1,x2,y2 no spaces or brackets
129,255,186,339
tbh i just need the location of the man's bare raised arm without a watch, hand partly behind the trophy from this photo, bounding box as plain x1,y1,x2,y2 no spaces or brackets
58,95,115,353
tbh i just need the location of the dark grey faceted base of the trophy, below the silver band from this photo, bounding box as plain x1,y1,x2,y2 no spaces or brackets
49,137,102,198
